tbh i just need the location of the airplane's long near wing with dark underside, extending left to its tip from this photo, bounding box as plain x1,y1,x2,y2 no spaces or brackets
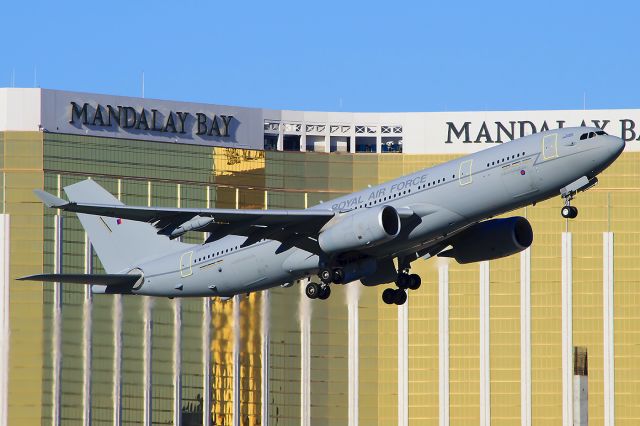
34,185,335,253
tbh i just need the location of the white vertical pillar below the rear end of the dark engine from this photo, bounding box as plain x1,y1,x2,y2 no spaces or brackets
438,265,449,426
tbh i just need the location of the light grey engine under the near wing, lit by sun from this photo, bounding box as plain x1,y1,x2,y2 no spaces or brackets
318,206,400,253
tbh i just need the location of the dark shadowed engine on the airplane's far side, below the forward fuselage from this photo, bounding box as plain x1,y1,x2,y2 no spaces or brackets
439,216,533,263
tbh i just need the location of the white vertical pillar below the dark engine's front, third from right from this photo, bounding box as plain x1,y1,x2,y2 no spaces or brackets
520,248,531,426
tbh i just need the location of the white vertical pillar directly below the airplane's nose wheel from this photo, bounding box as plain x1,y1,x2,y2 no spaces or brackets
562,232,573,425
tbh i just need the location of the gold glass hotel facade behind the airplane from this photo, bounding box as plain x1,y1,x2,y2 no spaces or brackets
0,132,640,425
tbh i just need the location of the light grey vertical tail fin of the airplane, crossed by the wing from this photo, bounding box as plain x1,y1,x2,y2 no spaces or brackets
62,179,187,274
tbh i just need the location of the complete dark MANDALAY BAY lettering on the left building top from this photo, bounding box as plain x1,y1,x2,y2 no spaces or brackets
69,102,233,137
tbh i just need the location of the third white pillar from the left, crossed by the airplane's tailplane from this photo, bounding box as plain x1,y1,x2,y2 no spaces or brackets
82,232,93,426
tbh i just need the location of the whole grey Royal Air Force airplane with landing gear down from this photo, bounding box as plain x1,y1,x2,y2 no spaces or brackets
21,127,625,305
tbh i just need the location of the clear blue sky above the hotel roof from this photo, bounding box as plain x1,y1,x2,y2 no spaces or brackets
0,0,640,111
